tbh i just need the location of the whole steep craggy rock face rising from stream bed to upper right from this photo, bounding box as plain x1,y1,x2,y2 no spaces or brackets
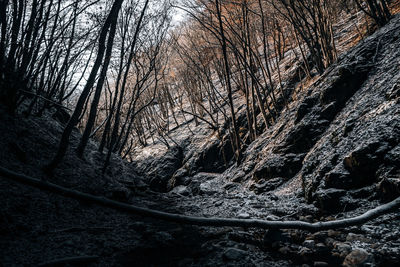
219,14,400,212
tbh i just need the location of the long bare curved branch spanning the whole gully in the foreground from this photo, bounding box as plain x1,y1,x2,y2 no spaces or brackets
0,167,400,232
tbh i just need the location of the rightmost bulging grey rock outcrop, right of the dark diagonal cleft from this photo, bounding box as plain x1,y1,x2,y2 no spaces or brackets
301,16,400,207
